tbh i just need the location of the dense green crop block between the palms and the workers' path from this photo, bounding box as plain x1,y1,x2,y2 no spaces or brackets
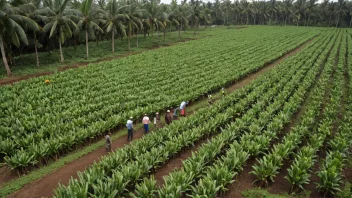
0,27,320,172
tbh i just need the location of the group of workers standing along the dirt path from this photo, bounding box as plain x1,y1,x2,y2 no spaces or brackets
105,88,226,152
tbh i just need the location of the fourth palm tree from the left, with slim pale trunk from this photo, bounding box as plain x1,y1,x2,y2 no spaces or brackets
71,0,104,59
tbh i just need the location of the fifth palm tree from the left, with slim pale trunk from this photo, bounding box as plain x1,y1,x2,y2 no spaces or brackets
101,0,126,53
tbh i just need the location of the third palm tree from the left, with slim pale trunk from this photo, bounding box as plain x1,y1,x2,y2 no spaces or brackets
43,0,77,63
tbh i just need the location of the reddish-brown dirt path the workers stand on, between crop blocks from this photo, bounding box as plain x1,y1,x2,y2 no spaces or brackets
8,40,312,198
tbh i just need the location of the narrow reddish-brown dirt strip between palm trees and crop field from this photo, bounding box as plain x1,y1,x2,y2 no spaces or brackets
0,37,195,86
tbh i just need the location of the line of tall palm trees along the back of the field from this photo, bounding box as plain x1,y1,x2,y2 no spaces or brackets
0,0,352,76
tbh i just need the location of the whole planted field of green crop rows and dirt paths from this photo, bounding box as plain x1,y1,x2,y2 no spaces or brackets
0,26,352,197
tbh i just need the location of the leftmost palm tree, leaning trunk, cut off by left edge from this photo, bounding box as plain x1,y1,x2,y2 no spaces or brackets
0,1,39,76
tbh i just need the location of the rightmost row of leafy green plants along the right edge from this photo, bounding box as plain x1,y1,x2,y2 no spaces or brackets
317,30,352,197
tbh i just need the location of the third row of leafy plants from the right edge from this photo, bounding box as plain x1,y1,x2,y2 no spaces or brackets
251,28,338,186
